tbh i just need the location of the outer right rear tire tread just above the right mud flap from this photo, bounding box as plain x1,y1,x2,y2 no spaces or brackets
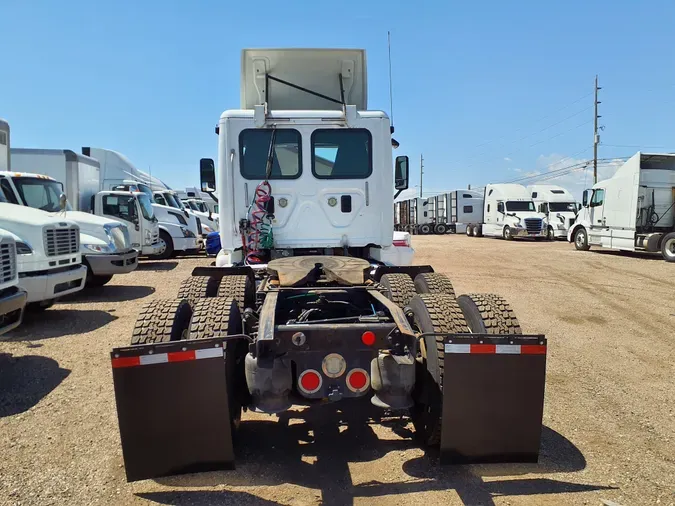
457,293,523,335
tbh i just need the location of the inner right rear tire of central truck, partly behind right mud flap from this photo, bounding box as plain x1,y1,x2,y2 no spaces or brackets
410,293,469,446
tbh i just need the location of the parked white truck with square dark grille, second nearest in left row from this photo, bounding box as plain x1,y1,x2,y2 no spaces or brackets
0,192,87,309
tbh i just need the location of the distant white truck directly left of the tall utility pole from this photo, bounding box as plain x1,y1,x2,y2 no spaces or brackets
527,184,579,240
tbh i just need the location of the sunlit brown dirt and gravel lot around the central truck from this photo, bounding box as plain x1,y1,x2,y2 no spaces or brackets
0,236,675,505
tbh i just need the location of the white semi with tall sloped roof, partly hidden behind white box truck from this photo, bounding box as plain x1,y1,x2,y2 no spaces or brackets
82,147,200,259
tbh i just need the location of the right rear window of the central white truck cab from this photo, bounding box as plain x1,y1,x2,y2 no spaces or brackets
312,128,373,179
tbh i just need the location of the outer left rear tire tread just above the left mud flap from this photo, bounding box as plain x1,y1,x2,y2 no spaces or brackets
131,299,192,345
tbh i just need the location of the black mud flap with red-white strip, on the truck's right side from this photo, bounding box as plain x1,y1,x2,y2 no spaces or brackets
441,334,546,464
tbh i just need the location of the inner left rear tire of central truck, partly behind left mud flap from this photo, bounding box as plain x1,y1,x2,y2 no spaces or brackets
188,297,250,430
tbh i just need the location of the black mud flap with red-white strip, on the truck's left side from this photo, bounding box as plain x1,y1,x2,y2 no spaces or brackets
111,338,234,481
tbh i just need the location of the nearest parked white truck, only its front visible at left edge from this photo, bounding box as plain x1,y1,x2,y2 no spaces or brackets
0,229,26,336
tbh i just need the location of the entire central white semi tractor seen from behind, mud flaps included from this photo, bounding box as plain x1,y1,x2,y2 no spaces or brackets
111,49,547,481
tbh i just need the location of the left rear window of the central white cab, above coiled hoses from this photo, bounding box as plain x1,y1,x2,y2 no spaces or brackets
239,128,302,180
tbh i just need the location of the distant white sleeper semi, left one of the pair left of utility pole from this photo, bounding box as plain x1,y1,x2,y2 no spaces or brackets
466,184,548,241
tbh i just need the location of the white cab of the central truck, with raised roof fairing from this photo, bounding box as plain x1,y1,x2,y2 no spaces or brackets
200,49,412,266
